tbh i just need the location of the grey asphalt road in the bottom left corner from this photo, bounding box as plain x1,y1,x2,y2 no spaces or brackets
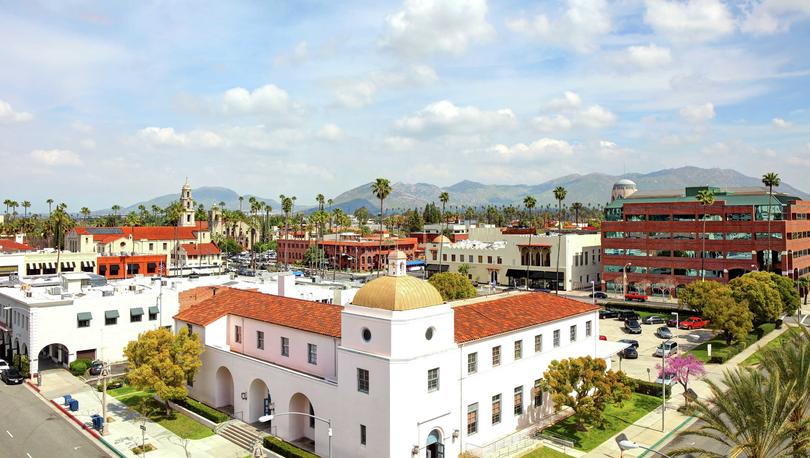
0,382,109,458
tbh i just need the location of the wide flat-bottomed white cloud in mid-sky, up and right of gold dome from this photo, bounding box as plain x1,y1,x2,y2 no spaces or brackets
396,100,516,134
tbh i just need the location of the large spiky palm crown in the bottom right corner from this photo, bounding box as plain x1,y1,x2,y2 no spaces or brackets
670,368,806,458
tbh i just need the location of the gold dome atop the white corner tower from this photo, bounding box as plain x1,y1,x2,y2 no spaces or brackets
352,275,444,311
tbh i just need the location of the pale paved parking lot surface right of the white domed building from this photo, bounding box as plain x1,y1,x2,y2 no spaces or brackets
599,313,714,382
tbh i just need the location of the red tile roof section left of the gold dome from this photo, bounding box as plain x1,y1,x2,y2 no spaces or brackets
174,287,343,337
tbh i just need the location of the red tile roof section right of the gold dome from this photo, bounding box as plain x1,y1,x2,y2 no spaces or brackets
453,293,599,343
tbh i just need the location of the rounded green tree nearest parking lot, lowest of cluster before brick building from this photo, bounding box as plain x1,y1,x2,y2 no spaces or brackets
701,282,754,345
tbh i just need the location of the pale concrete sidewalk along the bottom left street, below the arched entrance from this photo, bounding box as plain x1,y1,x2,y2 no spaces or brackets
48,385,245,458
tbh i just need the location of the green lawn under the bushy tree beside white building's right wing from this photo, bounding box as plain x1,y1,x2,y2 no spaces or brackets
541,393,661,456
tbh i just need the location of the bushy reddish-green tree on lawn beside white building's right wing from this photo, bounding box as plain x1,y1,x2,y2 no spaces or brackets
541,356,633,431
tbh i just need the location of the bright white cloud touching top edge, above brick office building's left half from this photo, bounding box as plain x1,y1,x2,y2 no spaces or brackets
644,0,734,42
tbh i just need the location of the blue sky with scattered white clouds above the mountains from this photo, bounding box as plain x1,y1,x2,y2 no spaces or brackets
0,0,810,211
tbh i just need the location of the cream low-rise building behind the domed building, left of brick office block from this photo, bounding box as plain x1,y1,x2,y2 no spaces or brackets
426,227,601,291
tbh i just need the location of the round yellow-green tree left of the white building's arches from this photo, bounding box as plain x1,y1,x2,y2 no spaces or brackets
124,328,203,413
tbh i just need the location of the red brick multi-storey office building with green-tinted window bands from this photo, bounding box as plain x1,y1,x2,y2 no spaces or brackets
601,186,810,294
